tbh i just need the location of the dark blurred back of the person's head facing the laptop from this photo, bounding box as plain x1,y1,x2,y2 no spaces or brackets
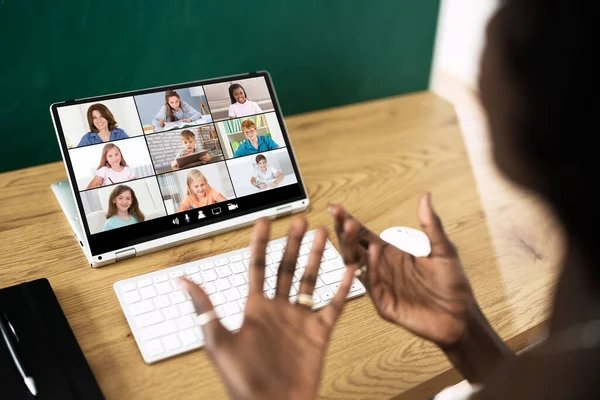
480,0,600,266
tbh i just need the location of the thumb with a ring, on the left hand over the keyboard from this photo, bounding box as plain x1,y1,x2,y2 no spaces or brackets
177,278,232,349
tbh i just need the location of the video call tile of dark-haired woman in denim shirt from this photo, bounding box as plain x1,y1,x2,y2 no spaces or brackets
58,97,143,149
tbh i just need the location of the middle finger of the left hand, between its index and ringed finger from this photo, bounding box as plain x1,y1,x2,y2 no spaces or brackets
275,218,308,300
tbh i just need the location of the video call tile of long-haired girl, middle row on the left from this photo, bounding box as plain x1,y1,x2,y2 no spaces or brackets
69,136,154,191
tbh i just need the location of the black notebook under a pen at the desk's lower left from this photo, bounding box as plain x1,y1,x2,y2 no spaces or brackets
0,279,104,400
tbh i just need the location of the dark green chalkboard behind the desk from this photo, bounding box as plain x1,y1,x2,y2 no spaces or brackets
0,0,439,172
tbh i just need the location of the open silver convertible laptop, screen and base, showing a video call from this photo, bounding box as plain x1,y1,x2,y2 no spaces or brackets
50,71,309,267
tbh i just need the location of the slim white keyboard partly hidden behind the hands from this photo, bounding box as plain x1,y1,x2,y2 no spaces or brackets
114,230,366,364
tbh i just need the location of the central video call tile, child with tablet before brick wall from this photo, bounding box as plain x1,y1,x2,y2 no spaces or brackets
146,124,224,174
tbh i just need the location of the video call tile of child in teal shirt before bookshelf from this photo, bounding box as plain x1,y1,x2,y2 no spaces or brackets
215,113,285,159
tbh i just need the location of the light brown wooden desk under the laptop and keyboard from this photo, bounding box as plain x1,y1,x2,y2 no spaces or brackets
0,93,558,399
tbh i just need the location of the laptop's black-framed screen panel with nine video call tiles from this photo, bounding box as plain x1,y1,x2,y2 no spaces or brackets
52,73,306,255
